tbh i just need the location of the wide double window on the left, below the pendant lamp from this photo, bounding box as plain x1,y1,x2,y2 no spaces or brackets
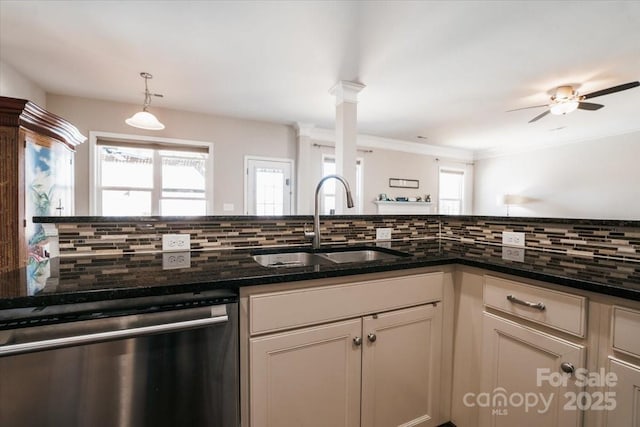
94,139,213,216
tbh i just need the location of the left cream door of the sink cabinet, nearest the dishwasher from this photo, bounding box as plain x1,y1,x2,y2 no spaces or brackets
249,319,362,427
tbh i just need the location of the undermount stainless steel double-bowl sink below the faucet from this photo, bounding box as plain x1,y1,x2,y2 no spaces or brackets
253,248,410,267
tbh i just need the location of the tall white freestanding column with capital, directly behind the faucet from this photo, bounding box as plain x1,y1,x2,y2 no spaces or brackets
329,80,365,213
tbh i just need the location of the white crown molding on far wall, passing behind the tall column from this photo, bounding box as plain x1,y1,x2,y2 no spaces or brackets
311,128,474,162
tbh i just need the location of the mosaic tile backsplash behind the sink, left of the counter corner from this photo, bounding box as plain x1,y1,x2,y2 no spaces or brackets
57,216,440,256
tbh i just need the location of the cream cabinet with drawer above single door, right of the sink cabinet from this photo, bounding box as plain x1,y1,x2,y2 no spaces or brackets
480,275,586,427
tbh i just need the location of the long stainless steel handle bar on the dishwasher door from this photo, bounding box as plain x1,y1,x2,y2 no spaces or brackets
0,315,229,357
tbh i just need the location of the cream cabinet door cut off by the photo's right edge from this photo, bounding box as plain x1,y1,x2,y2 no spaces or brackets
604,358,640,427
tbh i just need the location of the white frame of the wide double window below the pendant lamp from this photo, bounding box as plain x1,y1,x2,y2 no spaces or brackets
89,131,214,216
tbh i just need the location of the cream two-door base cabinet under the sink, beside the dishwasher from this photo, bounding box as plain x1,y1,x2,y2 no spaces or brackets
242,273,448,427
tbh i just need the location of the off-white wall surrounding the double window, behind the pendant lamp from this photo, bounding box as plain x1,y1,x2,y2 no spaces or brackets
47,94,296,215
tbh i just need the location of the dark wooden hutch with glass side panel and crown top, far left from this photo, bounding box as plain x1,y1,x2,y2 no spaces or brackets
0,97,86,280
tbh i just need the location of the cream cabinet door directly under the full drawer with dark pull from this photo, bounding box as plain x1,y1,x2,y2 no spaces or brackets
480,313,585,427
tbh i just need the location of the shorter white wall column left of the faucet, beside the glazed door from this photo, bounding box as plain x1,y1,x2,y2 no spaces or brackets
295,123,315,215
